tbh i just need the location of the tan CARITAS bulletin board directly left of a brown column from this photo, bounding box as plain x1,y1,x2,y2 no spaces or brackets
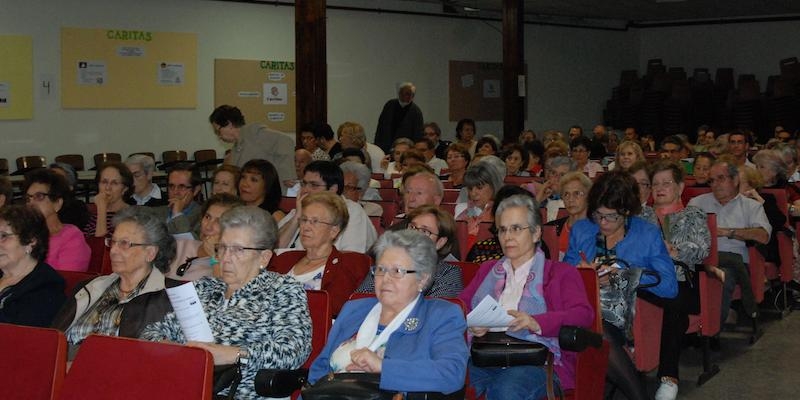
214,59,297,132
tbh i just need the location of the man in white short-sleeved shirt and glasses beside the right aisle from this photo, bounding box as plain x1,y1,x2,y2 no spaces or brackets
688,161,772,321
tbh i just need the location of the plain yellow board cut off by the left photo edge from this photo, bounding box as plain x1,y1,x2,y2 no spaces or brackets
0,35,33,120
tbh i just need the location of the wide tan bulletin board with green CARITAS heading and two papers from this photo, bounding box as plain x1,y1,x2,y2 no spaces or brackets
61,28,197,108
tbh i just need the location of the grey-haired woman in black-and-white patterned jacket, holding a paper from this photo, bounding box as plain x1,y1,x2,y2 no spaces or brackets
142,206,311,399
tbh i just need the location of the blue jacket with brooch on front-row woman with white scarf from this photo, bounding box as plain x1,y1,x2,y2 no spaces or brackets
308,297,469,394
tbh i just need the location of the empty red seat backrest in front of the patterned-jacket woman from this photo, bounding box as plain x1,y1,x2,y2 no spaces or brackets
61,334,214,400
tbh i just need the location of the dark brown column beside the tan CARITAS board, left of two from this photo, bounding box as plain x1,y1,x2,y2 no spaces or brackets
294,0,328,144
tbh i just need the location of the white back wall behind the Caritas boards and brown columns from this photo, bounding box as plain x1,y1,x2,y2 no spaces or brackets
0,0,640,169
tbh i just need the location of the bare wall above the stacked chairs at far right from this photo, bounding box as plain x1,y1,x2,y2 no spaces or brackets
636,21,800,87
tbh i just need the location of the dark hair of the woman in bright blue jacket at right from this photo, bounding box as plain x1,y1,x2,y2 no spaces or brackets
586,171,642,216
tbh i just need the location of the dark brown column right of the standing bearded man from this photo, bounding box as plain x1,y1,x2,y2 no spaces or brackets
503,0,527,143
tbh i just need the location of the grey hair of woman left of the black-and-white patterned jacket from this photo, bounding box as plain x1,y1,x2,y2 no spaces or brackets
114,207,177,273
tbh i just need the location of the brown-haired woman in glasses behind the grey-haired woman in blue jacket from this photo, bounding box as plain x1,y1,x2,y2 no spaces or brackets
356,205,464,298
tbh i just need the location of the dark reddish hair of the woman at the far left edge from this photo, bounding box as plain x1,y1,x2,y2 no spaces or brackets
0,205,50,262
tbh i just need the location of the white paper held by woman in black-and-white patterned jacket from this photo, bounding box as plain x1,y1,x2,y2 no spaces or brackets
167,282,214,343
